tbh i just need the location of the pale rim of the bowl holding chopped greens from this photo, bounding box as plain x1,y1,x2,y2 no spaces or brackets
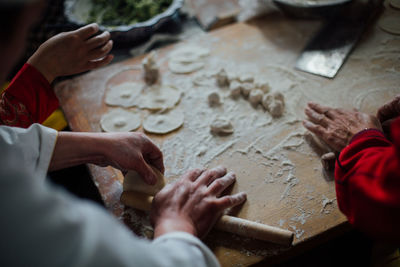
64,0,184,32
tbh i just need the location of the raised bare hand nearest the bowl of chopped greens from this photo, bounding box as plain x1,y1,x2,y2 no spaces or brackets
28,23,113,83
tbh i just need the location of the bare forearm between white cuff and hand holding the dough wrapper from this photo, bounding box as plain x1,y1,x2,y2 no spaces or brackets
49,132,108,171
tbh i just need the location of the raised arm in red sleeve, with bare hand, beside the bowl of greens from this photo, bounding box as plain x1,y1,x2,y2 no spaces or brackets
0,24,113,128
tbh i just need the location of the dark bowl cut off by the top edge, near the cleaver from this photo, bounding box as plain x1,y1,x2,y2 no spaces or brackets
273,0,352,19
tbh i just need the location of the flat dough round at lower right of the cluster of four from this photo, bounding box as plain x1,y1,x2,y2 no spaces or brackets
143,110,184,134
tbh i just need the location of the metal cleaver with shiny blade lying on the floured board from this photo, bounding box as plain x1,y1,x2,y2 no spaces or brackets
295,1,382,78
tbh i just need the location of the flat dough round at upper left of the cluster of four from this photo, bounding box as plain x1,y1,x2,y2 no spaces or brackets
105,82,143,107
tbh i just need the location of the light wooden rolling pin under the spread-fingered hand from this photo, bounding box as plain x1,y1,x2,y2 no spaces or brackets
121,191,293,246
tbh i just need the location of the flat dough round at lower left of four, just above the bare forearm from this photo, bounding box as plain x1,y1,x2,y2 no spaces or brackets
100,108,142,132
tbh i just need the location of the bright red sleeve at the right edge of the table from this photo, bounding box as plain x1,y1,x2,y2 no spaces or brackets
335,119,400,242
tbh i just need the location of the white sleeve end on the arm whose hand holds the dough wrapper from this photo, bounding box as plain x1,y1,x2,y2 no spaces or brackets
0,124,57,179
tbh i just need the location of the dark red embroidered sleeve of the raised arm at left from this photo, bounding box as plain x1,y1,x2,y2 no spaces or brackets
0,64,59,128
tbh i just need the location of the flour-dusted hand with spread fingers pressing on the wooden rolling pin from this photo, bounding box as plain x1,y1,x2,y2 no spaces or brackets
150,167,246,238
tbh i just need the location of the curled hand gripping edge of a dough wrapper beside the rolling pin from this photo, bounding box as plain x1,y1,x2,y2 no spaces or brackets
101,133,164,184
